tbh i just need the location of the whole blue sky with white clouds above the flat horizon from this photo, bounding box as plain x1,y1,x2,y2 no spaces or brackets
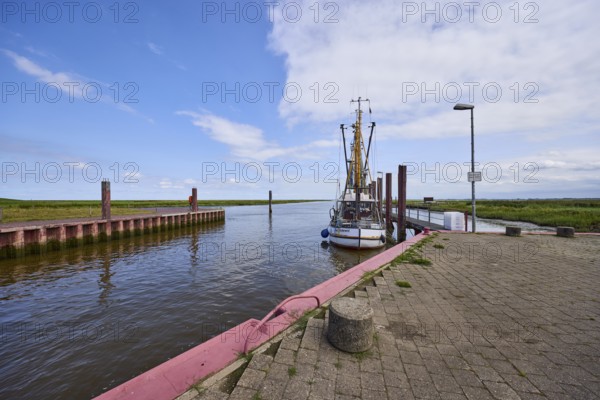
0,1,600,199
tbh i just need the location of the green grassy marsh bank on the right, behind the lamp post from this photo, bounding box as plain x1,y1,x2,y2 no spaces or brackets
407,199,600,232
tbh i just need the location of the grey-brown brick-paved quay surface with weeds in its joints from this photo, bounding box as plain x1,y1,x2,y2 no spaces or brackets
188,233,600,400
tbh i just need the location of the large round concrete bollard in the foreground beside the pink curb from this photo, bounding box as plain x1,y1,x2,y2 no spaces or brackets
327,297,374,353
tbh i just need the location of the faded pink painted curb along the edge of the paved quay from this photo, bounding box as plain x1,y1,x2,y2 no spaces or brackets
95,234,427,400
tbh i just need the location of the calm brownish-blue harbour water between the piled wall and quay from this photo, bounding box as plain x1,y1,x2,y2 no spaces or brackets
0,202,378,399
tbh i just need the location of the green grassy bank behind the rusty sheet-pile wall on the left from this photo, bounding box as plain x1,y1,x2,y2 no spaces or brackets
0,198,324,222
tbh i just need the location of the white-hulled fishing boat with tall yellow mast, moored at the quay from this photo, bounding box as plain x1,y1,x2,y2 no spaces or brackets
321,97,385,250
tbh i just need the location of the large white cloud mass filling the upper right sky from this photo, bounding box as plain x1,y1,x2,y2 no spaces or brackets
269,0,600,139
